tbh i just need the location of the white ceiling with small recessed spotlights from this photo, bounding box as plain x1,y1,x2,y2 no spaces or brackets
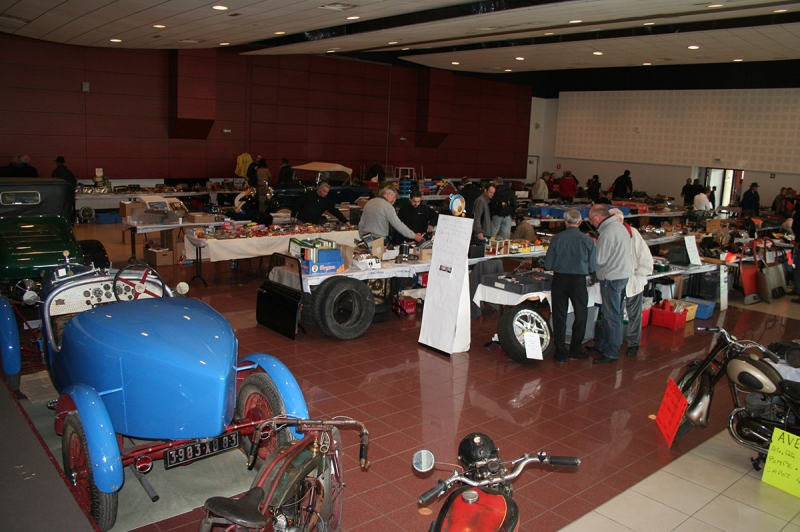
0,0,800,73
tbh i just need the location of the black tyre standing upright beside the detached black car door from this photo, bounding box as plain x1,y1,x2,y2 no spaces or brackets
314,277,375,340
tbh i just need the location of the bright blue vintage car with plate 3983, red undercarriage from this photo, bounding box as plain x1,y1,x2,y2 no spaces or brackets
0,262,308,530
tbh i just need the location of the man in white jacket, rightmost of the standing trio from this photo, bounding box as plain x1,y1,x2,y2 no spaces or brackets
608,209,653,357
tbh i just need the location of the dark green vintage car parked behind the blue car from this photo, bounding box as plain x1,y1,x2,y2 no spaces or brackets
0,178,109,295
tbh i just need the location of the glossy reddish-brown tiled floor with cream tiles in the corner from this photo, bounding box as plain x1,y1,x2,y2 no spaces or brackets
61,225,800,532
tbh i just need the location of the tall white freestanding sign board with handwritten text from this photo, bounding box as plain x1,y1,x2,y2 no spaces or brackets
419,216,472,354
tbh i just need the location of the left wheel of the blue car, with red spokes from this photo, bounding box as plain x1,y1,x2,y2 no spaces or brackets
61,412,117,532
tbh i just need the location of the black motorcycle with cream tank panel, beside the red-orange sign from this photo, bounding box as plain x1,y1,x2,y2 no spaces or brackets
677,327,800,470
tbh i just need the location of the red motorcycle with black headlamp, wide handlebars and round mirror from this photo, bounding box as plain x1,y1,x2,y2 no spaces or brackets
413,432,581,532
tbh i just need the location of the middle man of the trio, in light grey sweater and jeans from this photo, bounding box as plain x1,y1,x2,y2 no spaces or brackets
589,204,632,364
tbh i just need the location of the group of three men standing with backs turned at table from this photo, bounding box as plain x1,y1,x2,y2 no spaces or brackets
545,203,653,364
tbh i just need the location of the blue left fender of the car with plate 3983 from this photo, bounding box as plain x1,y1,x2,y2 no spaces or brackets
56,384,125,493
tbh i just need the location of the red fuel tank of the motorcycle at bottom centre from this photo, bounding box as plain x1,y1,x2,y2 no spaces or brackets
431,486,519,532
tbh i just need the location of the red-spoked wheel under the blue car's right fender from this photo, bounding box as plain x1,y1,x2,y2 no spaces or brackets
234,373,295,468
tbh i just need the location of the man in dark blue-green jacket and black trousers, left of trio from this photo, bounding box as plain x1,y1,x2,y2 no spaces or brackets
544,209,596,364
